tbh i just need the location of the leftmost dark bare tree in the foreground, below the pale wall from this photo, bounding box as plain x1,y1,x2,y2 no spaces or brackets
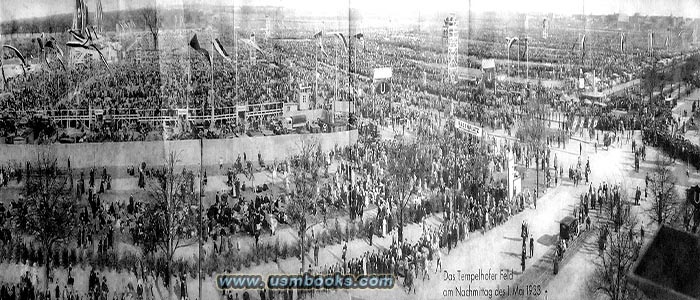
12,153,77,289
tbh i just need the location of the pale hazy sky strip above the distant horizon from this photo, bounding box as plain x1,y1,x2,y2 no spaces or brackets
0,0,700,22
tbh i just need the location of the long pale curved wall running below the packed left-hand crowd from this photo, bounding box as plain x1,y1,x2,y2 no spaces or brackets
0,130,358,168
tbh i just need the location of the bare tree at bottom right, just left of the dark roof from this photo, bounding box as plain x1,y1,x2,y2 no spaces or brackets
588,213,641,300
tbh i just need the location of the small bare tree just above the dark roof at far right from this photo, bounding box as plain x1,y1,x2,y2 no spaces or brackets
647,157,679,225
